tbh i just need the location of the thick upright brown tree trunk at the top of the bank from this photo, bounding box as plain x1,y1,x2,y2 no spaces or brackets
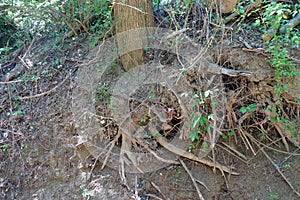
114,0,154,71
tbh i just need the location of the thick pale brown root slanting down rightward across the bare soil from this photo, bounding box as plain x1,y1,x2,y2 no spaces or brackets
155,135,239,175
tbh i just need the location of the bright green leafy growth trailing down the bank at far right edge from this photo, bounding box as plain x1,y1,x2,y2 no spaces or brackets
254,2,300,95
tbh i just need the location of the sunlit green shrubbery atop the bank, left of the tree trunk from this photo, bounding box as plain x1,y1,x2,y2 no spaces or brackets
0,0,112,55
